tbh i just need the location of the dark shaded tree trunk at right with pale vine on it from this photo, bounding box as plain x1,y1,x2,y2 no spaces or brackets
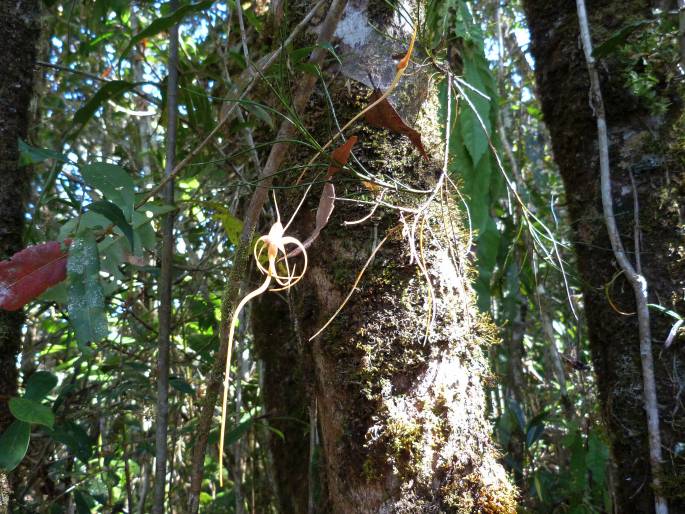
524,0,685,513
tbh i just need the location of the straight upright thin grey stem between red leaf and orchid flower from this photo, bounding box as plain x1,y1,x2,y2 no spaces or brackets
152,6,178,508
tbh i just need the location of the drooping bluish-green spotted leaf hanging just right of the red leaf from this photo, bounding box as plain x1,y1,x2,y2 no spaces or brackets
67,230,107,344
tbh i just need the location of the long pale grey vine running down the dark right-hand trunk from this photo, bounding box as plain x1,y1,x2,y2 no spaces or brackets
576,0,668,514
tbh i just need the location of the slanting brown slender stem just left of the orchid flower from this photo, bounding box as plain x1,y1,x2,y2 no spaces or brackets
188,0,347,508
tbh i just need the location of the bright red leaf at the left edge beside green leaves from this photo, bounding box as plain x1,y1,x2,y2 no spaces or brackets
0,240,71,311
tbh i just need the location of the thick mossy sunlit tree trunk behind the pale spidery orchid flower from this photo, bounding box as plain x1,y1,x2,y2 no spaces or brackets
254,2,515,514
